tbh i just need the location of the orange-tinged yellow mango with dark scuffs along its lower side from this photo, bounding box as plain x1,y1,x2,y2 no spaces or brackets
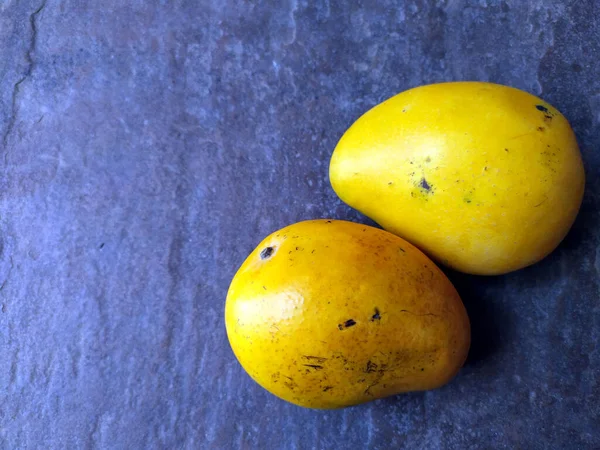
225,220,470,408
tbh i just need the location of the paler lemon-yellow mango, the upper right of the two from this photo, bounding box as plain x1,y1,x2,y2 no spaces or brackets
329,82,585,275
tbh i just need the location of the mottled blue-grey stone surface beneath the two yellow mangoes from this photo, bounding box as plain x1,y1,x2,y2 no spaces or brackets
0,0,600,449
